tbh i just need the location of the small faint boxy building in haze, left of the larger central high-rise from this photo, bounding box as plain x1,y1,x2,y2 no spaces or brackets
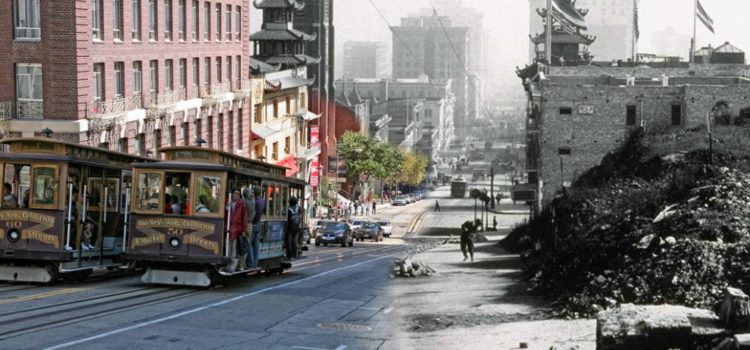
341,41,390,79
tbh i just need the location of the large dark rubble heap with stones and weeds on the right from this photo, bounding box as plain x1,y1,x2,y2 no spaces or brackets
501,128,750,317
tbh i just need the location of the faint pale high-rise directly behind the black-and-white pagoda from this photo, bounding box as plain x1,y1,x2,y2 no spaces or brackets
529,0,639,61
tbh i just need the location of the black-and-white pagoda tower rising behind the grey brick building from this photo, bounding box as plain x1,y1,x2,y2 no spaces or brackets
529,0,596,66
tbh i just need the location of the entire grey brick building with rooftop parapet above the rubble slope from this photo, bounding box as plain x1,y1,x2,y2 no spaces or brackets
518,64,750,213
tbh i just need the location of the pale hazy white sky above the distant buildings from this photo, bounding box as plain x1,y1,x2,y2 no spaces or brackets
252,0,750,85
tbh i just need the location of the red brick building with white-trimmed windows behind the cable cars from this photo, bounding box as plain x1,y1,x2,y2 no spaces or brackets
0,0,252,155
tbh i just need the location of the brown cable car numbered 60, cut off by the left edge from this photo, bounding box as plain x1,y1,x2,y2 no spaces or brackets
0,137,151,283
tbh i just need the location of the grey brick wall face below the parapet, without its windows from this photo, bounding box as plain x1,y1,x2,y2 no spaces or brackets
539,83,750,201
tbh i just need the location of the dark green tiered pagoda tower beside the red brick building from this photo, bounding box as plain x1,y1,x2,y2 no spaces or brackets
250,0,320,74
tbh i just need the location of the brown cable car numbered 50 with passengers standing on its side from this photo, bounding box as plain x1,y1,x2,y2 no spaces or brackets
126,146,305,287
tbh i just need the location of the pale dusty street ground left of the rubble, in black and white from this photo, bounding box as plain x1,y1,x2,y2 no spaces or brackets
384,239,596,350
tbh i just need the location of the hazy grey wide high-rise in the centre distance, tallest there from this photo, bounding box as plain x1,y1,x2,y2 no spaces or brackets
393,17,476,136
